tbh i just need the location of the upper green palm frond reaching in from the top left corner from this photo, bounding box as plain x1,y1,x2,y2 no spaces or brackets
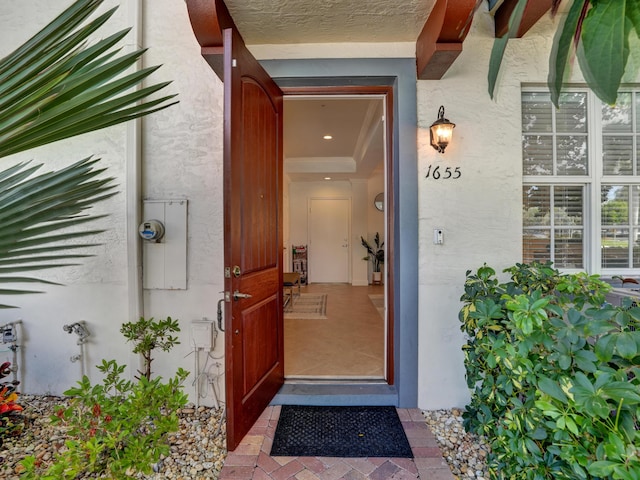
0,0,177,157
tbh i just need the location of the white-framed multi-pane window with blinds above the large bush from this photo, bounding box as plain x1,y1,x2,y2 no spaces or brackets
522,89,640,274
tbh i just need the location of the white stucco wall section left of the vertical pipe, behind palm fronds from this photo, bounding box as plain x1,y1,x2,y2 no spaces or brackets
0,0,130,394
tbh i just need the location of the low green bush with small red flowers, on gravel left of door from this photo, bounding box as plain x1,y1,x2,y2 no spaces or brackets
22,360,188,480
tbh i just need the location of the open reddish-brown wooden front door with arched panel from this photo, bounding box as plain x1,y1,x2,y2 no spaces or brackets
223,28,284,450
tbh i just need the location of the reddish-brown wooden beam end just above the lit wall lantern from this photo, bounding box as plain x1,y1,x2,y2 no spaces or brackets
416,0,476,80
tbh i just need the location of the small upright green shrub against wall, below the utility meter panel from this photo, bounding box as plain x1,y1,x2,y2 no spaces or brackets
120,317,180,380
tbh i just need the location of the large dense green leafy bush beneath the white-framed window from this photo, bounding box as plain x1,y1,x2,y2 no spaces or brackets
459,263,640,480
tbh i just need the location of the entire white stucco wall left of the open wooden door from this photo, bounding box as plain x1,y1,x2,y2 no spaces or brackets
0,0,223,404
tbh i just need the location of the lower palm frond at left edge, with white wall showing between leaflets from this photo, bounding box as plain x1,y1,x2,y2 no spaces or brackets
0,157,115,308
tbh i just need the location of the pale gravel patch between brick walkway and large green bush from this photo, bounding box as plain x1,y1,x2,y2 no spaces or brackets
424,409,489,480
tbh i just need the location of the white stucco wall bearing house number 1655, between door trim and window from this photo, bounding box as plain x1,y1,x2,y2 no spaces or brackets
417,12,596,409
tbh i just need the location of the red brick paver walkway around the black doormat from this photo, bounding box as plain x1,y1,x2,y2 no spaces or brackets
219,406,454,480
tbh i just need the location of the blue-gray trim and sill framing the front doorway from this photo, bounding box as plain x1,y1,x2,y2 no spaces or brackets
260,58,418,408
